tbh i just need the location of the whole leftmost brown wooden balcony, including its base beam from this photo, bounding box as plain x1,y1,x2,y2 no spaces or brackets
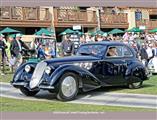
0,7,51,27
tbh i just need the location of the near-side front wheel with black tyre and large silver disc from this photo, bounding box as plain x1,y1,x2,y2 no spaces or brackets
57,72,78,101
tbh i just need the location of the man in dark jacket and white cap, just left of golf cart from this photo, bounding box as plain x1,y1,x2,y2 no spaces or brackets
10,33,29,67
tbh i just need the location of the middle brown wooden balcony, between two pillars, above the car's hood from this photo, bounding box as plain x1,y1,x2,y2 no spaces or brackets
54,9,97,27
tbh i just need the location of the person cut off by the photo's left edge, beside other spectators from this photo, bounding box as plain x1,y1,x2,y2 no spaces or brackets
0,34,7,75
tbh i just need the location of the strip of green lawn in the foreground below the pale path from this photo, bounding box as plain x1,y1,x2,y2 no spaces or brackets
0,97,155,112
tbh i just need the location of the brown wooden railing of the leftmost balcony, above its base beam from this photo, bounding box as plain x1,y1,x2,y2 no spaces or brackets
0,7,50,21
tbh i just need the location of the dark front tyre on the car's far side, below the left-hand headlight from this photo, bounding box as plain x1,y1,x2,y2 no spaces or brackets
20,87,39,96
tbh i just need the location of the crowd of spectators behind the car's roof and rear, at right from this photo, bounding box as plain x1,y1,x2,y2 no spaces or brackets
80,32,157,67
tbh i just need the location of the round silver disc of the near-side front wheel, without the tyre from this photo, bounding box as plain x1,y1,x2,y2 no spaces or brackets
61,76,77,97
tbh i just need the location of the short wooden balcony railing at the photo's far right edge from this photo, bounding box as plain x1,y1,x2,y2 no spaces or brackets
136,20,157,30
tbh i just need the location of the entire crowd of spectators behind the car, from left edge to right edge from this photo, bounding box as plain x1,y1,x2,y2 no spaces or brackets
0,32,157,75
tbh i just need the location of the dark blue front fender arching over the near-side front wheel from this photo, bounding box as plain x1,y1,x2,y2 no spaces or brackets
50,65,100,87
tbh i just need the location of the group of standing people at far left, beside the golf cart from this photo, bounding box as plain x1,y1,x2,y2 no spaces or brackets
0,34,29,75
